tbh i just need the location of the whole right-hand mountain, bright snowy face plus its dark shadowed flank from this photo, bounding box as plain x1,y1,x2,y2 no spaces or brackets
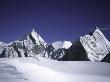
61,28,110,62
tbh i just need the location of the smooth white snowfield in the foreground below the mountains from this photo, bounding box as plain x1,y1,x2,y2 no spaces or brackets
0,58,110,82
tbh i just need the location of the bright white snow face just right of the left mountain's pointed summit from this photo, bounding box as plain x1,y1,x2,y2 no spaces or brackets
30,29,47,46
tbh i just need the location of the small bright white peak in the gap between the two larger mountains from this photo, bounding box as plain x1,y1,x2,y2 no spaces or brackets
52,41,72,50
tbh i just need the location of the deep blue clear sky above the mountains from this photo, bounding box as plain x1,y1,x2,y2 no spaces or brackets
0,0,110,42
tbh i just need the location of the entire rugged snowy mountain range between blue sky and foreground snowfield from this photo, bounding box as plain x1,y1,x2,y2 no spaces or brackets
0,28,110,62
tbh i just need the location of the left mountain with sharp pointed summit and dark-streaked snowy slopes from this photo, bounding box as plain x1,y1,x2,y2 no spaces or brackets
0,29,47,58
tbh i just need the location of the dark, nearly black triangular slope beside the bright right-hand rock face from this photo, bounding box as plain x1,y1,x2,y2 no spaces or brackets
61,40,89,61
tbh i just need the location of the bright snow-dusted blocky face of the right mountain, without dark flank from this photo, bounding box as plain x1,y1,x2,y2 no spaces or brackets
80,28,110,61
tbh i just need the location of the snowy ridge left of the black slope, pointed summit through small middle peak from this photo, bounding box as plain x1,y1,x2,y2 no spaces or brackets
0,29,72,60
